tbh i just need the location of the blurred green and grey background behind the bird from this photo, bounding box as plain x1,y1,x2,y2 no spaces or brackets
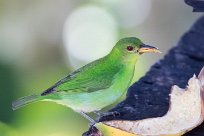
0,0,200,136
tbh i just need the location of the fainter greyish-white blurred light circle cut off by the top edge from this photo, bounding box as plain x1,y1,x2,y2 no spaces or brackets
92,0,152,28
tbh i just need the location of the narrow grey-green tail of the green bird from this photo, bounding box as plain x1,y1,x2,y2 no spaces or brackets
12,95,41,110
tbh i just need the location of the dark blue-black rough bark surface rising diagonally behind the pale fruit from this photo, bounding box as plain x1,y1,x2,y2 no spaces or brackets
97,16,204,136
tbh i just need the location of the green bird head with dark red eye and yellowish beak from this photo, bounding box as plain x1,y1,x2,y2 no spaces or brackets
113,37,161,59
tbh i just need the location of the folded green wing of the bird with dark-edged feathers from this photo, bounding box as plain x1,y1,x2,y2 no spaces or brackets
41,59,120,95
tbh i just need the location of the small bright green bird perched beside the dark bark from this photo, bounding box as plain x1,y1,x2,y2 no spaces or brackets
12,37,160,115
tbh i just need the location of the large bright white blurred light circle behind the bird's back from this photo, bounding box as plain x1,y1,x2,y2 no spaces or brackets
64,5,118,68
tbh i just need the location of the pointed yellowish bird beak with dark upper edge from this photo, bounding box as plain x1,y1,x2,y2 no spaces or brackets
137,44,162,54
